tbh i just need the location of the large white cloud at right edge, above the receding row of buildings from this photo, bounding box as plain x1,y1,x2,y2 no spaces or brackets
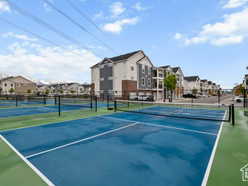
174,8,248,46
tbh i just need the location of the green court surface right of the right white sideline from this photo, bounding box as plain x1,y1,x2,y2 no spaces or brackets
207,109,248,186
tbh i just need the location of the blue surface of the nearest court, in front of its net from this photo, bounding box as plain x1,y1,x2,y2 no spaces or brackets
1,107,225,186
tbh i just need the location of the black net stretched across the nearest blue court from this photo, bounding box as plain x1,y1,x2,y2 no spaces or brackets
114,100,233,122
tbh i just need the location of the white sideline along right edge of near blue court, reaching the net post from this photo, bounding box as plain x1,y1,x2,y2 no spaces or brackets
201,111,227,186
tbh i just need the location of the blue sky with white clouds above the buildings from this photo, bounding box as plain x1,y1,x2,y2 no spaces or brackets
0,0,248,88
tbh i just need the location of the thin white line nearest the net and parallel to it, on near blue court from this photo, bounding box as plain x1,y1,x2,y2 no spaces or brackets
102,116,217,136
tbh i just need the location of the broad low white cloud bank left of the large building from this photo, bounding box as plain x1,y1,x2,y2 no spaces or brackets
0,42,100,82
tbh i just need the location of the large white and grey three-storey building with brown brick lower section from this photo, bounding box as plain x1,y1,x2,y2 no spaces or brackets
91,50,155,99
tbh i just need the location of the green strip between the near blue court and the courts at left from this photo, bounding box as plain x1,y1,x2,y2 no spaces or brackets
0,109,111,131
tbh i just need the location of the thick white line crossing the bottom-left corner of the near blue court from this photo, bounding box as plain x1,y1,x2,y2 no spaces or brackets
0,135,55,186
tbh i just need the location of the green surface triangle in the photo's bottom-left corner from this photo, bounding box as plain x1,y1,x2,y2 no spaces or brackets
0,139,46,186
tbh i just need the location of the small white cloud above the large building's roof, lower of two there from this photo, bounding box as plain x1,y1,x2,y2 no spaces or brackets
103,17,139,34
